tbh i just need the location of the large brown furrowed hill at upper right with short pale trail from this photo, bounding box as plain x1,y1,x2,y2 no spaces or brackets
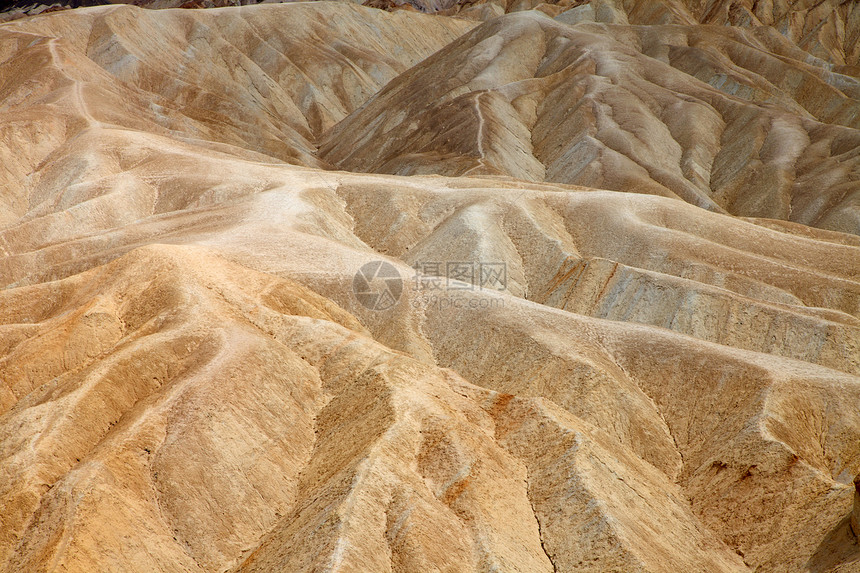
321,11,860,234
